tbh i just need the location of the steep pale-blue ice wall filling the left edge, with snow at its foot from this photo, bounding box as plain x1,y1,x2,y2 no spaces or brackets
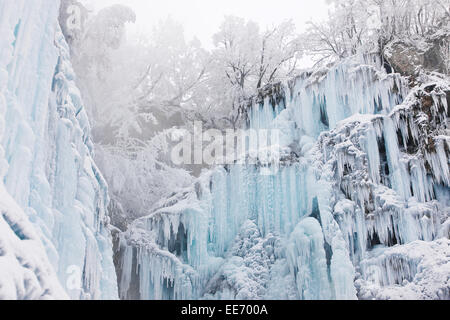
0,0,117,299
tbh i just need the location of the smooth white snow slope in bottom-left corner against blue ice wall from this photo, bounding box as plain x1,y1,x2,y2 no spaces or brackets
0,183,68,300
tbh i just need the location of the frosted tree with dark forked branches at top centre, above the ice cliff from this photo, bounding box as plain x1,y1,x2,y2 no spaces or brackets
212,16,302,125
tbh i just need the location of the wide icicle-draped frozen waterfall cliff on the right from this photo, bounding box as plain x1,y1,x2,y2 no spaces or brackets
119,53,450,299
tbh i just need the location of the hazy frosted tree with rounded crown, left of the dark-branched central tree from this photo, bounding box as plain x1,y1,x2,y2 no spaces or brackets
127,18,210,136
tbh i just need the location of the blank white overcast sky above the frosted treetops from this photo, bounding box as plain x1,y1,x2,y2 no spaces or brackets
82,0,328,47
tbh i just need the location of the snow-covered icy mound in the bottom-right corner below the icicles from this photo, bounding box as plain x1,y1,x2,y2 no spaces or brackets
357,239,450,300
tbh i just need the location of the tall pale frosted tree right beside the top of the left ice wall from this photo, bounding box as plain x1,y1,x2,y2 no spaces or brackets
64,1,136,143
